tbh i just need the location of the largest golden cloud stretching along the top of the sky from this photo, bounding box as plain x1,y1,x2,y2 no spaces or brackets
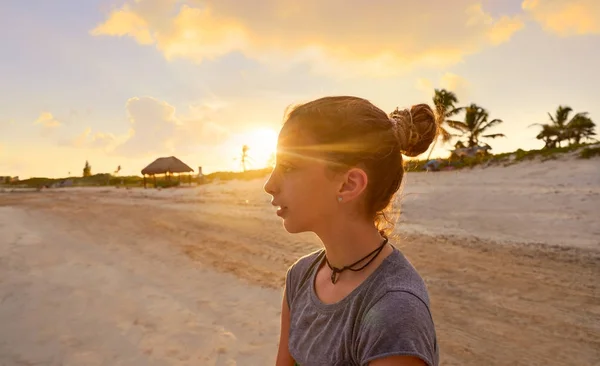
91,0,523,76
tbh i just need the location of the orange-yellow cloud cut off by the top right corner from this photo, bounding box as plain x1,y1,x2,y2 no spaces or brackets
521,0,600,36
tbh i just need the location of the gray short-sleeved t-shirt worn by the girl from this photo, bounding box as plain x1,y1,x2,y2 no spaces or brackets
286,248,439,366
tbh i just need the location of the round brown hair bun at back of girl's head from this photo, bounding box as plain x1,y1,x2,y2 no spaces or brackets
392,104,438,156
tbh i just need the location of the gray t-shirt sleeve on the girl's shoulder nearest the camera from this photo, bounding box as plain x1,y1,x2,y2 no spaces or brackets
357,291,438,366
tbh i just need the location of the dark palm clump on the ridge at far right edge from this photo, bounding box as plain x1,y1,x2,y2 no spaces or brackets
529,105,596,148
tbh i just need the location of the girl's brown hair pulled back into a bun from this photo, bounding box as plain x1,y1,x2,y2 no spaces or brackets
283,96,438,234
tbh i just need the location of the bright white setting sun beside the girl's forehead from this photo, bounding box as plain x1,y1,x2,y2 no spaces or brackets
230,127,278,169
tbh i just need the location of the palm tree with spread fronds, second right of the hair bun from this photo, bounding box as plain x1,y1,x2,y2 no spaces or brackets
446,103,506,147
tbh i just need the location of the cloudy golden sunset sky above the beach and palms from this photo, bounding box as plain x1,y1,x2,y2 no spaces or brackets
0,0,600,178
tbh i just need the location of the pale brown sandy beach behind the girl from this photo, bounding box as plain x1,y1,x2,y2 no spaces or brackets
0,153,600,365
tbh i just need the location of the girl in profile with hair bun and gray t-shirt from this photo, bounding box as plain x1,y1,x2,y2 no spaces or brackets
264,96,439,366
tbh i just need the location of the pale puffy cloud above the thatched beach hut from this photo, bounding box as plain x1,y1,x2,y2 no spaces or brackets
113,97,228,157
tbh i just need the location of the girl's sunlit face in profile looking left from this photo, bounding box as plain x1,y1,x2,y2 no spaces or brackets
264,129,341,233
